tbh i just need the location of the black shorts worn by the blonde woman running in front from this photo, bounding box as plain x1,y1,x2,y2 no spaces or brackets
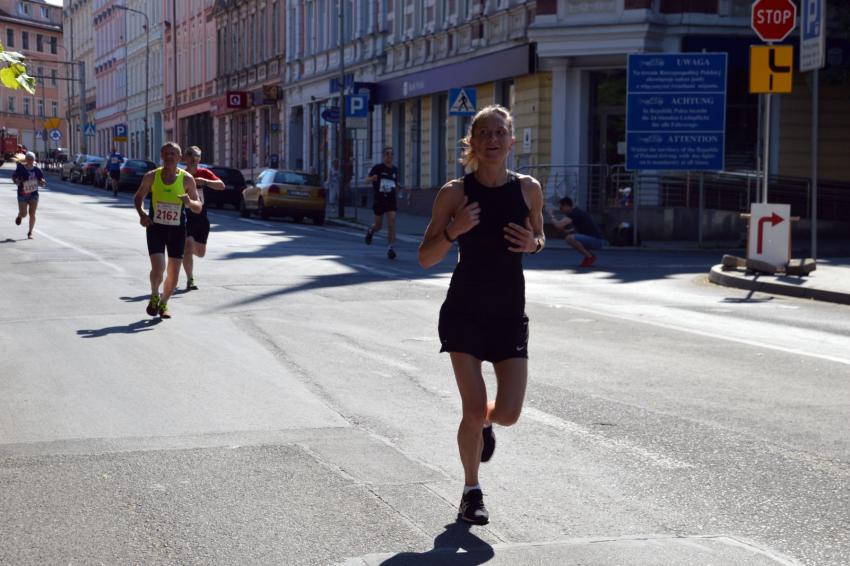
439,307,528,364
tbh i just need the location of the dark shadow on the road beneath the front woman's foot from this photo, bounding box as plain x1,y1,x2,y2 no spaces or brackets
381,521,496,566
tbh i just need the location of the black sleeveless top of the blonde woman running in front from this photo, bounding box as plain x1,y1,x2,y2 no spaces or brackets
444,173,529,317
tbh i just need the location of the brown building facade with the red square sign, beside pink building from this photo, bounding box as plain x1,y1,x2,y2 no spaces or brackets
213,0,285,177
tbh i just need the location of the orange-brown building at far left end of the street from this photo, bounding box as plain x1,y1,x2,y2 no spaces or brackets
0,0,68,155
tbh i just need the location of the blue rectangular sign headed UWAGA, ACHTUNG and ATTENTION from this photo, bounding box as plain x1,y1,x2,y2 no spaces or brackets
626,53,727,171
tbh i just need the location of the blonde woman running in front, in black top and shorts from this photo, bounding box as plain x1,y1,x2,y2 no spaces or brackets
419,105,546,525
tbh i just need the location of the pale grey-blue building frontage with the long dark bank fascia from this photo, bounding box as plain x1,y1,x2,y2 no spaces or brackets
284,0,536,197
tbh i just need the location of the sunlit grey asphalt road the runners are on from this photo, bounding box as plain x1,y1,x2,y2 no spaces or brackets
0,169,850,565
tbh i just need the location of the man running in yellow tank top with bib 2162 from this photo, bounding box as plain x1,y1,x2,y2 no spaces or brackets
134,142,203,318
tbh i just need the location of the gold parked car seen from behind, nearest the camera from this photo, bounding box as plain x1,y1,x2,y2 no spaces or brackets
239,169,327,225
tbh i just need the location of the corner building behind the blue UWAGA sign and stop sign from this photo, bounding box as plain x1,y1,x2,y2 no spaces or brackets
529,0,850,210
